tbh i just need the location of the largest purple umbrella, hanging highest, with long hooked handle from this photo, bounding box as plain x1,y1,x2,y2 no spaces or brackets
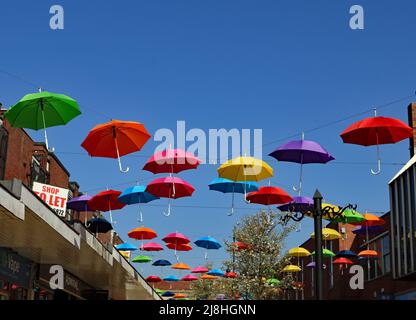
269,133,335,196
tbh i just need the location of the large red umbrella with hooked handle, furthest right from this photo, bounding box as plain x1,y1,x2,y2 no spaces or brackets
341,110,413,174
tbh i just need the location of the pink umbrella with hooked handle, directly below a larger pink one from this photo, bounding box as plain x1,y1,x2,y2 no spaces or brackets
146,177,195,216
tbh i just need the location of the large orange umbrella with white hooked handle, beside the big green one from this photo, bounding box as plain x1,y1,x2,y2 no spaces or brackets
81,120,150,172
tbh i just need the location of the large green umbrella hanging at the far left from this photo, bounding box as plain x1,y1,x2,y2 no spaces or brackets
4,89,81,150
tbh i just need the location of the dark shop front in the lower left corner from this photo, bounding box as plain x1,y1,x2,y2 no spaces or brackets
0,248,33,300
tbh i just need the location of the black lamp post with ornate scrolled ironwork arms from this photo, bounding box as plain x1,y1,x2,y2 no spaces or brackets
281,189,357,300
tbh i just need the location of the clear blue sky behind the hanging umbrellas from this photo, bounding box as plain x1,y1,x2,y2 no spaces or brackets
0,0,416,275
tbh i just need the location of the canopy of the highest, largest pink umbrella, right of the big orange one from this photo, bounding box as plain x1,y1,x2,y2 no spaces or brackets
143,149,202,174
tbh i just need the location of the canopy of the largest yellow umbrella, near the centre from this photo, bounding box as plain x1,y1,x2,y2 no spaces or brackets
218,157,273,181
